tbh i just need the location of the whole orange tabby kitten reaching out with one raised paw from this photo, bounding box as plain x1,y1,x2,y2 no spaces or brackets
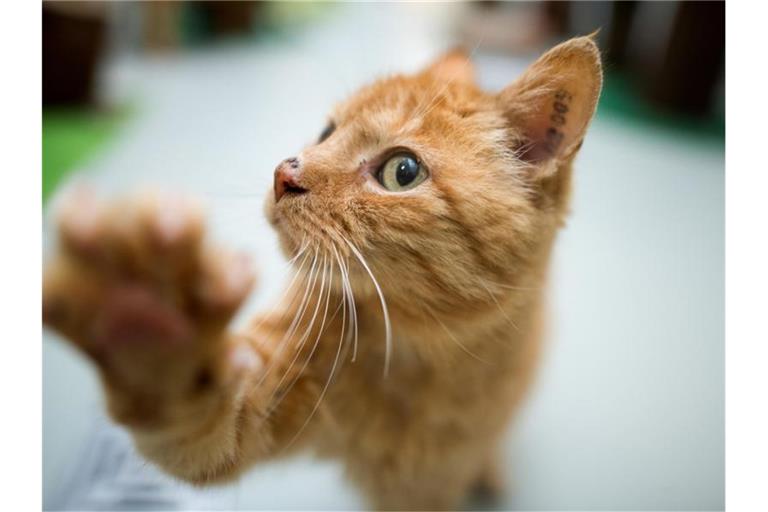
43,37,602,509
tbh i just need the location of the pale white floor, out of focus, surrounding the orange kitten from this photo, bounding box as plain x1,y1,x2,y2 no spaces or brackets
43,4,724,510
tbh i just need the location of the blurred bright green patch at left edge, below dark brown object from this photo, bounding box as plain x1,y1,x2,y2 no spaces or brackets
43,107,127,203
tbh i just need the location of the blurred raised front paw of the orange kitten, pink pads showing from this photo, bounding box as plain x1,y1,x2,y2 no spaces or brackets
43,190,253,410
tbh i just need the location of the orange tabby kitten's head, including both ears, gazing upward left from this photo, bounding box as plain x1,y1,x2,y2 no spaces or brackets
266,37,602,311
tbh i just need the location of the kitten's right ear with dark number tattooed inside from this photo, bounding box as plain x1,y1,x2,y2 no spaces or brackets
499,36,603,177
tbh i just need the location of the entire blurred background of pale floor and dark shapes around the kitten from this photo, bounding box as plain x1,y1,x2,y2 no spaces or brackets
42,1,725,510
